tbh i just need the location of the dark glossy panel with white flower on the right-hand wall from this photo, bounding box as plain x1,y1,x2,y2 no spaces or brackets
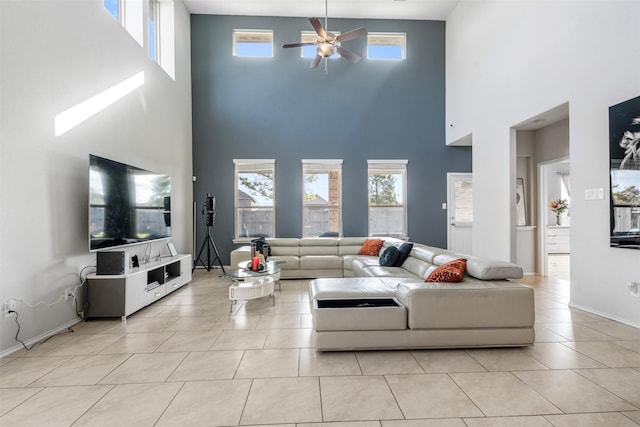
609,96,640,249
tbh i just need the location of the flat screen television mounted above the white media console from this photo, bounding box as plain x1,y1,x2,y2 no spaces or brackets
89,154,171,251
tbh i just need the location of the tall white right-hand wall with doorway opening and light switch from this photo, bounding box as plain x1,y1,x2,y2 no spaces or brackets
446,0,640,326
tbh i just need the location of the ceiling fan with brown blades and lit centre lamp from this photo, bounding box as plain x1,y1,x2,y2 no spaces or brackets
282,0,367,73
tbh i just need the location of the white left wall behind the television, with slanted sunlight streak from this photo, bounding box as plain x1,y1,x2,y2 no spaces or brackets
0,0,192,354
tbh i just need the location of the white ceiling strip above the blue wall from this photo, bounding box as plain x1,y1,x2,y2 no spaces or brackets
183,0,460,21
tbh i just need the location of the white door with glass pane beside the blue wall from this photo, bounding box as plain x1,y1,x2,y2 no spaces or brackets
447,173,473,254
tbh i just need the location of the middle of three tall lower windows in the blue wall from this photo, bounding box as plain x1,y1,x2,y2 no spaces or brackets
302,159,342,237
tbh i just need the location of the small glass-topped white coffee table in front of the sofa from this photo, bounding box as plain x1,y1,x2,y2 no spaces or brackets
221,261,284,311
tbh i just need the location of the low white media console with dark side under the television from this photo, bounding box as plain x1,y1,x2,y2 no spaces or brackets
84,255,191,321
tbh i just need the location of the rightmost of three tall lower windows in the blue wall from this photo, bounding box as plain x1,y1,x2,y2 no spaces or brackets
368,160,407,238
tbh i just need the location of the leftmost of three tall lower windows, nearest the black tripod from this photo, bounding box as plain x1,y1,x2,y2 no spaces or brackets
233,159,275,240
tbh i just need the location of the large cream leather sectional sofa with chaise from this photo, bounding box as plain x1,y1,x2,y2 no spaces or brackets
231,237,535,350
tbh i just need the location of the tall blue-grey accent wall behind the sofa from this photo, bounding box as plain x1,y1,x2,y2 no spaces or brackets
191,15,471,264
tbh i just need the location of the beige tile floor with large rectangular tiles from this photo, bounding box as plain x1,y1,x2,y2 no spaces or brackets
0,270,640,427
